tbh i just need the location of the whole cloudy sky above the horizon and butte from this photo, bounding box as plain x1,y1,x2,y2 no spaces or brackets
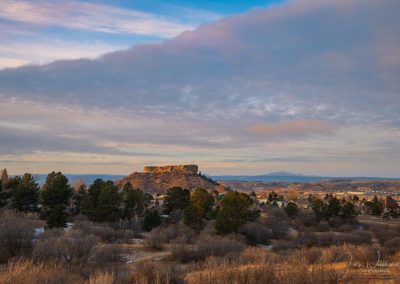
0,0,400,177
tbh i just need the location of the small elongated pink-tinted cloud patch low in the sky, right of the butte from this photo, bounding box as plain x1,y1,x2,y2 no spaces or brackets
249,119,337,137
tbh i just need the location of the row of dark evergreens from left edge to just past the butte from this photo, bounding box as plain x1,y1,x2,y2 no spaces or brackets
0,172,259,234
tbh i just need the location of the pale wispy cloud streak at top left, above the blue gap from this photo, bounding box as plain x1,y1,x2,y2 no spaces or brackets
0,0,211,37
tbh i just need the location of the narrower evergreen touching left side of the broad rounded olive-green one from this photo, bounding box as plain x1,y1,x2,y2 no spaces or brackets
184,188,214,232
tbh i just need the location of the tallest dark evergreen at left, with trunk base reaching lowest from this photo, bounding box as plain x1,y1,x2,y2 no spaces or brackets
41,172,72,228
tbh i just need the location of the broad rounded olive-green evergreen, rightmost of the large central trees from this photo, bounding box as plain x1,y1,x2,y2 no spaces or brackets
215,191,259,234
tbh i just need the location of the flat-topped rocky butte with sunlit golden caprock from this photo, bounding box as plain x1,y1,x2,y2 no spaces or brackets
116,165,224,194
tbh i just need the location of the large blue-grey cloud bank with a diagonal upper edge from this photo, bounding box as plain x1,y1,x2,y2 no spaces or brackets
0,0,400,120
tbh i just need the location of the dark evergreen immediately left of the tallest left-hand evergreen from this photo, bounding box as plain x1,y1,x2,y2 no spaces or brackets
9,173,40,212
